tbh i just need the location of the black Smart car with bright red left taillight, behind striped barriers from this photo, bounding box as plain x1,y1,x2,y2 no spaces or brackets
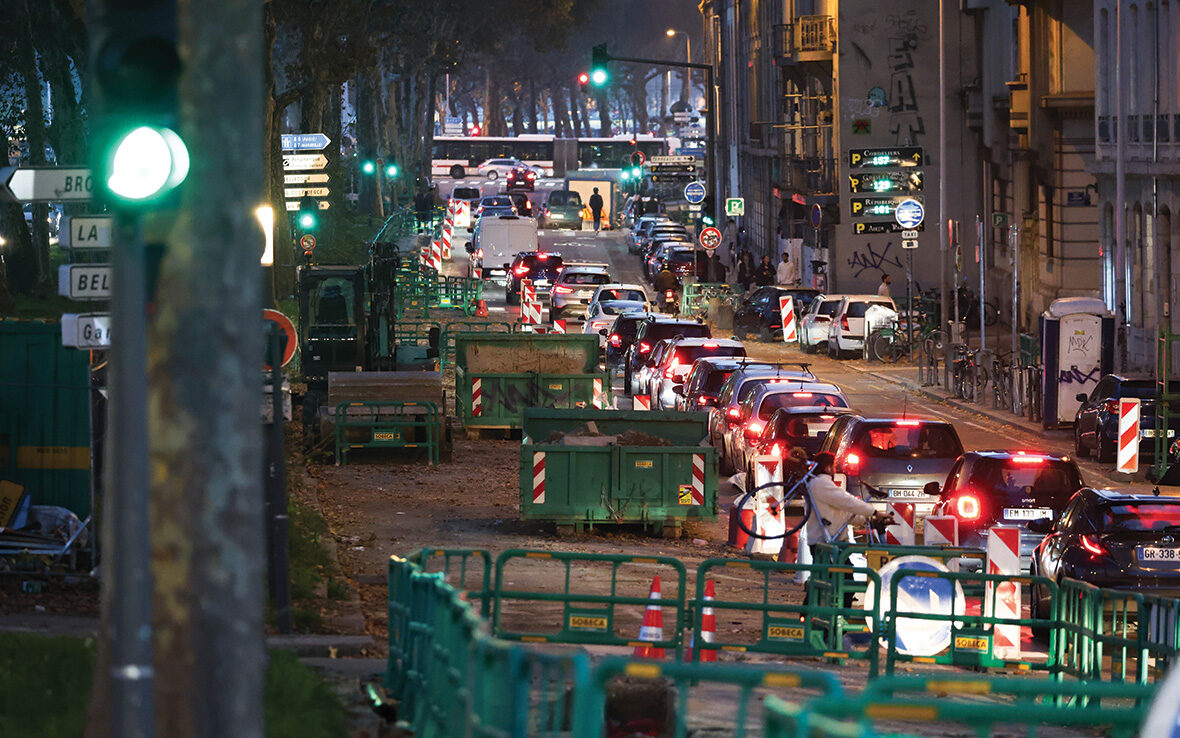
926,451,1083,568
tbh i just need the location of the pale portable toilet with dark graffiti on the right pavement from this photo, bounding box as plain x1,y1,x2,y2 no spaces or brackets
1041,298,1114,429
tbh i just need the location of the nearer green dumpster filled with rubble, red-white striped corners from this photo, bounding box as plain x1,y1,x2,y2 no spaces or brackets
520,409,717,536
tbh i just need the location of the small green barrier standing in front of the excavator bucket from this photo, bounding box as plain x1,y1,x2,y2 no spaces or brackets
335,400,441,466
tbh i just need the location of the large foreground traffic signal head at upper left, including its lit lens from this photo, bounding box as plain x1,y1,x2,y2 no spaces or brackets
89,0,189,207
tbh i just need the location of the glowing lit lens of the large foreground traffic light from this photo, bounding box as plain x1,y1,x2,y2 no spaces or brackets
106,125,189,201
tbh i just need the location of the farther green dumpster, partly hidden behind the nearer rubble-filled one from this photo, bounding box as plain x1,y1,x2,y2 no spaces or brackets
454,333,610,429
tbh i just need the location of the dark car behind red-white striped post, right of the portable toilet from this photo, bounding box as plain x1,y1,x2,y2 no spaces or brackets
1074,374,1180,463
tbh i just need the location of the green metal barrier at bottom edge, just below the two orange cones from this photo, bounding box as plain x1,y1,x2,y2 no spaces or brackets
579,658,843,738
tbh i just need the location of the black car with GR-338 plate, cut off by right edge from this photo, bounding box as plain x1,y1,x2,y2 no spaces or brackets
1029,486,1180,618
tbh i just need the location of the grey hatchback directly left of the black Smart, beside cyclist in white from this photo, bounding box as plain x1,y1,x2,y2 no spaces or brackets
820,414,963,517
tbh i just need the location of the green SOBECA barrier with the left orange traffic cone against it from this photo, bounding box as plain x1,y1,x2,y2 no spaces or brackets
492,549,688,654
